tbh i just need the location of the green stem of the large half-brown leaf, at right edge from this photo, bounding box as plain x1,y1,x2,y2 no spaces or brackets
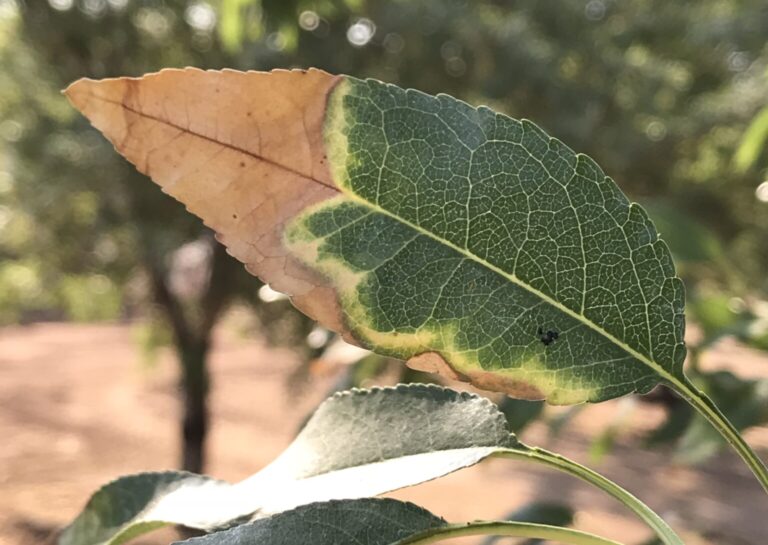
667,377,768,492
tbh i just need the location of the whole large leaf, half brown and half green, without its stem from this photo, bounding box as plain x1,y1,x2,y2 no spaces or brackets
67,69,685,404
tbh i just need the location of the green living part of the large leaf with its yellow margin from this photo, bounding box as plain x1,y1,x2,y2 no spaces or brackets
286,74,685,404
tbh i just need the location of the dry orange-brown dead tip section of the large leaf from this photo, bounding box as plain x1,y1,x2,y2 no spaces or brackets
65,68,349,336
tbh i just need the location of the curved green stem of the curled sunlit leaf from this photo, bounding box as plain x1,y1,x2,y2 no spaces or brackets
492,443,683,545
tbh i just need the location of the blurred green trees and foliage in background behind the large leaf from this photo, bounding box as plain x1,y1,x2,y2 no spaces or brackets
0,0,768,470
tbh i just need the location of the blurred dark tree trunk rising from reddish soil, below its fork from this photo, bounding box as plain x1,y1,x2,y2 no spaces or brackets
179,343,209,473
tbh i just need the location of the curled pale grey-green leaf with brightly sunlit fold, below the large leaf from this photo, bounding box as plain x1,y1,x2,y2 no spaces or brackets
58,384,518,545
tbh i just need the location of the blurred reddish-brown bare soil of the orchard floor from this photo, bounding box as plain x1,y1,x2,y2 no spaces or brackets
0,324,768,545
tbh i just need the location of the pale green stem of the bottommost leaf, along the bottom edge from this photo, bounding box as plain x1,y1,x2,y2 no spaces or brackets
397,521,621,545
